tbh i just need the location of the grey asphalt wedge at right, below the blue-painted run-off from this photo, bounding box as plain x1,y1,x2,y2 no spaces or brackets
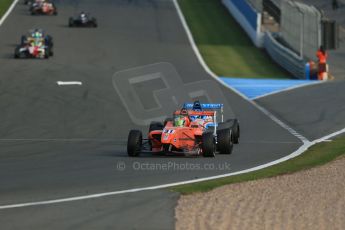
257,78,345,140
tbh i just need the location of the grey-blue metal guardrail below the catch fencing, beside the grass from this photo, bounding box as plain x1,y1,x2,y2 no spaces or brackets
264,32,306,79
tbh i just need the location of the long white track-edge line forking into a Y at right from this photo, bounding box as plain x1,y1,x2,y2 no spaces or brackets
0,0,345,210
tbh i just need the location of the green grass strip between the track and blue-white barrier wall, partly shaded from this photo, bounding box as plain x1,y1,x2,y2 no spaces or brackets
178,0,290,78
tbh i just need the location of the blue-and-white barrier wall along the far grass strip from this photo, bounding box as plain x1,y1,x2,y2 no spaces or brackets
222,0,264,47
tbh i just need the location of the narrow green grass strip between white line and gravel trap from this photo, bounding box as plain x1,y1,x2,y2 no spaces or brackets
172,137,345,194
